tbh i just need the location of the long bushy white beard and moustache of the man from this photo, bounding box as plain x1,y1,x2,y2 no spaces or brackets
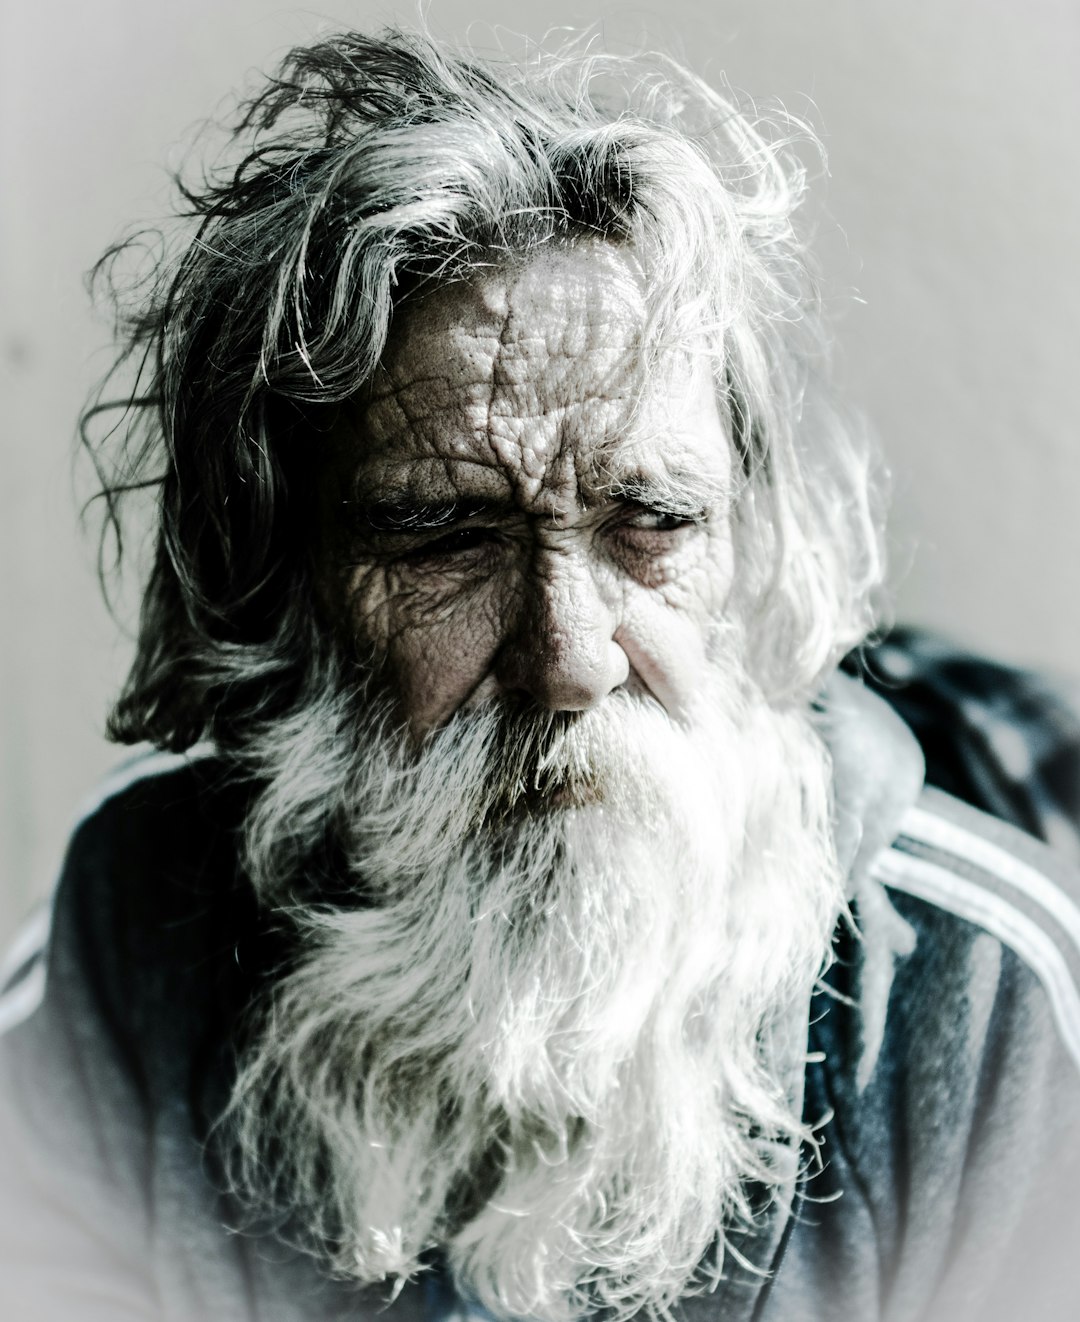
226,661,842,1322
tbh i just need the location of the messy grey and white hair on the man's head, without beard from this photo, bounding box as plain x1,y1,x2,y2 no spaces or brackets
83,23,880,748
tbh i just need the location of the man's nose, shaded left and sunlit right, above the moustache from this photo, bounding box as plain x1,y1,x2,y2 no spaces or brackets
494,554,629,711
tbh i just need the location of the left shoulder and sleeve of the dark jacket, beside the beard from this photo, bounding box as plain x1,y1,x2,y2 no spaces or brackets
0,754,293,1318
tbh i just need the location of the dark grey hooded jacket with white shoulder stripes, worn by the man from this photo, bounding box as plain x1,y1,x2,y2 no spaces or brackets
0,681,1080,1322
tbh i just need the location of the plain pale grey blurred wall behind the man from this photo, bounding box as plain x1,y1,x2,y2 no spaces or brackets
0,0,1080,947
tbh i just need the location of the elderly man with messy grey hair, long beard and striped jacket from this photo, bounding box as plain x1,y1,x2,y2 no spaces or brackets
0,23,1080,1322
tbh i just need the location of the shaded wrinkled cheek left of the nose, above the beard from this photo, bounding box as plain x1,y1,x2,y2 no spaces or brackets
349,567,505,735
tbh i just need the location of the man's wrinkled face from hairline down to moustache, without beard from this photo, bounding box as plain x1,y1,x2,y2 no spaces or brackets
336,242,732,738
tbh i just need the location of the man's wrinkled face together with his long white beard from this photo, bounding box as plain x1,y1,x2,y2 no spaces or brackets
229,243,842,1322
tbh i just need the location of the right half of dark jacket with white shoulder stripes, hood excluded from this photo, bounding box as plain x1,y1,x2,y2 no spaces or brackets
806,789,1080,1322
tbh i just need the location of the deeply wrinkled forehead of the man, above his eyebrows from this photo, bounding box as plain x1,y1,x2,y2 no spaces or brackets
333,242,716,512
